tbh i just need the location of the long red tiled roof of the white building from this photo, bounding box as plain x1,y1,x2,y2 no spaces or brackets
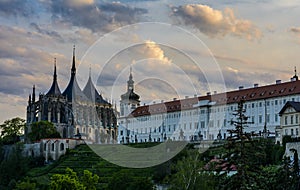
131,80,300,117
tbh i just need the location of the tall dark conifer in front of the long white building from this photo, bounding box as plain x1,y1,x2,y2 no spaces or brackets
220,100,265,189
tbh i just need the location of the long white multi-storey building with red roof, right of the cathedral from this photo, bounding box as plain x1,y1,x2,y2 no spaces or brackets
118,71,300,143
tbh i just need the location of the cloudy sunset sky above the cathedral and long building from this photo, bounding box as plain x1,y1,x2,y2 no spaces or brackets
0,0,300,123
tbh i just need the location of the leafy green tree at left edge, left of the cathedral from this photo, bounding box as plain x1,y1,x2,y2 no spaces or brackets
0,117,25,144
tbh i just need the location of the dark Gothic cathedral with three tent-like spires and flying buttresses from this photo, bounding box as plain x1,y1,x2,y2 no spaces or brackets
25,47,117,143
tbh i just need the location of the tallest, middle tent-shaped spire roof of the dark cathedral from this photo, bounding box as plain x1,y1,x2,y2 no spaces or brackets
62,46,82,102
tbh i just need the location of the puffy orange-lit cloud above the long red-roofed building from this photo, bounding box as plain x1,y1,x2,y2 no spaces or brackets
172,4,262,40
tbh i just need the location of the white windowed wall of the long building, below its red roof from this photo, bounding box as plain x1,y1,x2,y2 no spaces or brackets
118,95,300,142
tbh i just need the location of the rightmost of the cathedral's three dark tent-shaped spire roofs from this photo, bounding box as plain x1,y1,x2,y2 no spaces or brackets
83,68,109,105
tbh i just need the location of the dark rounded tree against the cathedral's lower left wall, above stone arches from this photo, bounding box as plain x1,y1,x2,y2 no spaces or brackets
28,121,60,142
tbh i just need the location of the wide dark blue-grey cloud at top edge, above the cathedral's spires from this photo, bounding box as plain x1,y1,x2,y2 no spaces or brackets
50,0,147,32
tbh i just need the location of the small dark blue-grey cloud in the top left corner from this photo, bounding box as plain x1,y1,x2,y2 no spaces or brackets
0,0,34,17
